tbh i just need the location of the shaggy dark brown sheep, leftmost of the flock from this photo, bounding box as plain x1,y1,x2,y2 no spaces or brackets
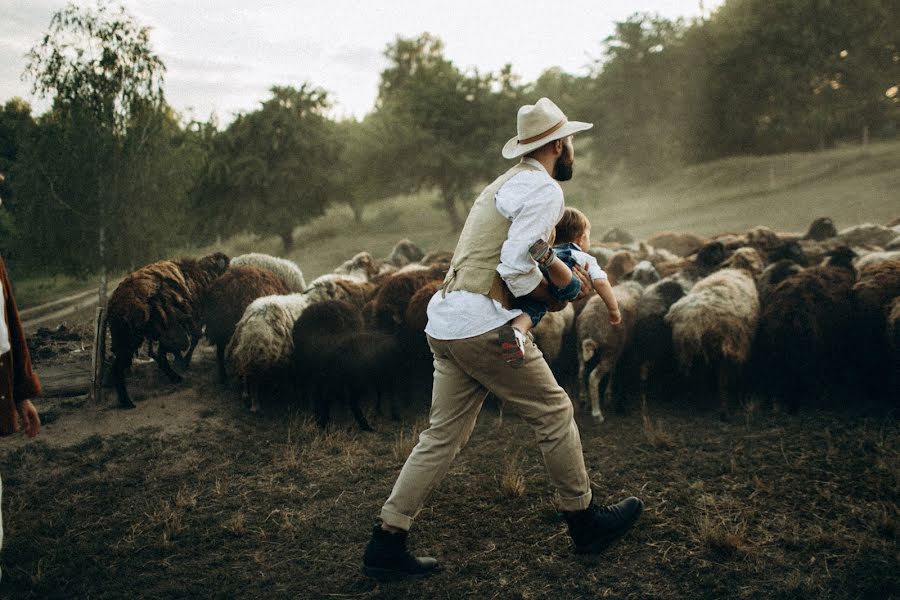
107,252,228,408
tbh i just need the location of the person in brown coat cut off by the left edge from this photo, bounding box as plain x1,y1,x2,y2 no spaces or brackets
0,257,41,437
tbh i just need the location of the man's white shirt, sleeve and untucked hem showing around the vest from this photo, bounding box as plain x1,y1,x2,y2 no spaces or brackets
425,158,565,340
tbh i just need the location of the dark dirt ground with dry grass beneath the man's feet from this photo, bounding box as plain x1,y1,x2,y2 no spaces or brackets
0,330,900,599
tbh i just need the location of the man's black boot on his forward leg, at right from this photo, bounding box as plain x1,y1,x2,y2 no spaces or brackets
563,496,644,554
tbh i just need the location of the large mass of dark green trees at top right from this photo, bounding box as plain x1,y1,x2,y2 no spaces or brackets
584,0,900,179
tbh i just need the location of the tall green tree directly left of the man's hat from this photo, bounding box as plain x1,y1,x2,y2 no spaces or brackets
376,33,521,230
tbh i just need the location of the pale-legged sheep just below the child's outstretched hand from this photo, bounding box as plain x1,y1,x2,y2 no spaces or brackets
575,281,643,423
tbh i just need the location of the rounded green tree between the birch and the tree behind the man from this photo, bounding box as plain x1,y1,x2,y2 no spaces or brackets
194,84,339,252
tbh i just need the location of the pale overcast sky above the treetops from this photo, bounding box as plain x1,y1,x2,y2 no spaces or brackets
0,0,723,124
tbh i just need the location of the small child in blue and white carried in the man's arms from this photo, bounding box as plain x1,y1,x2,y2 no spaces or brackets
500,208,622,368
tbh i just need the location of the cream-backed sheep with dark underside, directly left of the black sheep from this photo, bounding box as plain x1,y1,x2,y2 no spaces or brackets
225,294,310,411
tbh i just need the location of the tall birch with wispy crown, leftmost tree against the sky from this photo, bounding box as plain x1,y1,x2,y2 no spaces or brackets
26,2,165,302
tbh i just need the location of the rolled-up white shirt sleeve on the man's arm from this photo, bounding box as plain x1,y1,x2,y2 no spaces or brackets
496,173,565,297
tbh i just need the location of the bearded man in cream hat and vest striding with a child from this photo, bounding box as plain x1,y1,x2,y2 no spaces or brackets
363,98,643,580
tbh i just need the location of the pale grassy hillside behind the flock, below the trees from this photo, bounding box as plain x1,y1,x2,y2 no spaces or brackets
16,141,900,314
